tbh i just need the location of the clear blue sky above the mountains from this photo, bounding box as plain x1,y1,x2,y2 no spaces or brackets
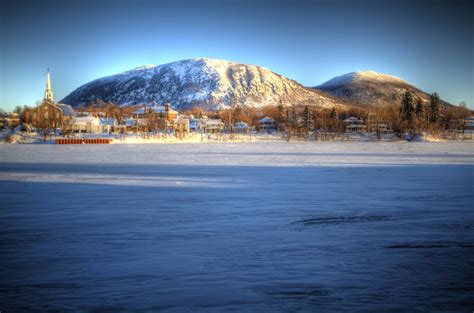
0,0,474,110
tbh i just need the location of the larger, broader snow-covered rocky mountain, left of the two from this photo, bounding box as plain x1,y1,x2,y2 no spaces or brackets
61,58,343,110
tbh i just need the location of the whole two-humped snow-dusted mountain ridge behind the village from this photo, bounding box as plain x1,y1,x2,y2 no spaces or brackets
61,57,449,111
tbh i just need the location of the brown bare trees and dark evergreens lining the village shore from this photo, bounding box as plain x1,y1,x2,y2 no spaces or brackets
5,90,472,136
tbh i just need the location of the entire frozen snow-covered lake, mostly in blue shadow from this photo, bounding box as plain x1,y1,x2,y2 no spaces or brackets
0,142,474,312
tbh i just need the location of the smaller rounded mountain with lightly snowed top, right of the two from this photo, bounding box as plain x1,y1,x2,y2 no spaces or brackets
314,71,438,105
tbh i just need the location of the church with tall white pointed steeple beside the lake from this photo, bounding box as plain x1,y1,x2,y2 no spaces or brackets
32,70,75,130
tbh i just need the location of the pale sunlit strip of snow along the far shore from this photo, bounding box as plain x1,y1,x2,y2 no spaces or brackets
0,141,474,166
